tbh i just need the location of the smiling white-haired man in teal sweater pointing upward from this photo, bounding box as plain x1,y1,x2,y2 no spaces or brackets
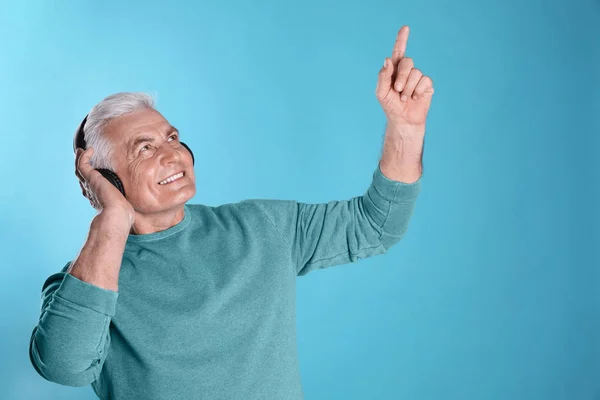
29,27,433,400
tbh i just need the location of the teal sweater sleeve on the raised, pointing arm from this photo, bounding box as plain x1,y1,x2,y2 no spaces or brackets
247,164,421,276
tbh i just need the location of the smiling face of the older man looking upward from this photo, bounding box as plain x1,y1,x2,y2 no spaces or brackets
104,109,196,214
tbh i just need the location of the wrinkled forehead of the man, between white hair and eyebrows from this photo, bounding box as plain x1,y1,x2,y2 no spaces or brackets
104,108,172,145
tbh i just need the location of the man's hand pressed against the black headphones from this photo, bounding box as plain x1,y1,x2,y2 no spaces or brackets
75,147,135,228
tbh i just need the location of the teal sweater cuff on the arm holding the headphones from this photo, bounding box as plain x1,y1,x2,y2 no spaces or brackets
54,273,119,317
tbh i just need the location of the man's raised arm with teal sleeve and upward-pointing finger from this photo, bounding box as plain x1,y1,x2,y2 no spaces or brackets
250,26,433,275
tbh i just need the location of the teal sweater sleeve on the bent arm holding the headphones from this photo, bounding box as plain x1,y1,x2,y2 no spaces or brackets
29,262,118,386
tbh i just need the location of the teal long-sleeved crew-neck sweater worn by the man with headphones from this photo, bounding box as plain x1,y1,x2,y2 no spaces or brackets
29,166,421,400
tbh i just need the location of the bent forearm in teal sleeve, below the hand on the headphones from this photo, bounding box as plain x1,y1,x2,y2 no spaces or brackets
29,210,129,386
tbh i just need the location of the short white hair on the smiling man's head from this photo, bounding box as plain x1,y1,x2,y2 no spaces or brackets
83,92,155,171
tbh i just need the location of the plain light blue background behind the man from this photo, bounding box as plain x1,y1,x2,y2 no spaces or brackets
0,0,600,400
